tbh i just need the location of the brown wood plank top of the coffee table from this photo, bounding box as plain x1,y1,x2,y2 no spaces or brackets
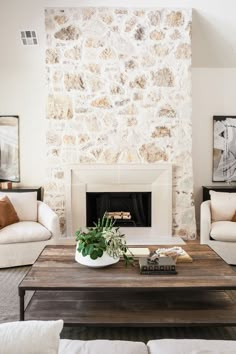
19,244,236,291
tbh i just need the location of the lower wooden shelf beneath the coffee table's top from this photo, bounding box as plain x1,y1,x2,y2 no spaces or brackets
25,291,236,327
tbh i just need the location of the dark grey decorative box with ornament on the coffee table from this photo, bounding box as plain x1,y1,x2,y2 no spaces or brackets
139,253,177,275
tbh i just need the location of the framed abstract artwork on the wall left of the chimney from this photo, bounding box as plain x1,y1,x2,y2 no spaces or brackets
0,115,20,182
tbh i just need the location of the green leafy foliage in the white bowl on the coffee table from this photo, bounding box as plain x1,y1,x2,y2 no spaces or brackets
75,214,133,265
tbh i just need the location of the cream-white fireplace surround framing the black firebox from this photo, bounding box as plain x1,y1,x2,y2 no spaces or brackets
64,162,172,244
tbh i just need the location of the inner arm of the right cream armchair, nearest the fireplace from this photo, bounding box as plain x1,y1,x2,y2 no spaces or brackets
200,200,211,244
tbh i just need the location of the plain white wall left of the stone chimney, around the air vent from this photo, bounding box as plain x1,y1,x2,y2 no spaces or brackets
0,0,46,186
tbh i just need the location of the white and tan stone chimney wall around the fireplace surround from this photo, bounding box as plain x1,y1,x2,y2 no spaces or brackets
45,7,196,238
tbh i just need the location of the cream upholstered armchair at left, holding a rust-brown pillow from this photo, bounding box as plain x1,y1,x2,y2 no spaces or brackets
0,192,60,268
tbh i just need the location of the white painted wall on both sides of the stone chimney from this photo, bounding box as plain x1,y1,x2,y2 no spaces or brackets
0,0,236,230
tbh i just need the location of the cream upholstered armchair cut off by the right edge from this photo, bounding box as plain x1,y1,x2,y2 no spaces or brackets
200,190,236,265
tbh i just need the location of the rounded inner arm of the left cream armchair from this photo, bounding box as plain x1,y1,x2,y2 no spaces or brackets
37,200,61,238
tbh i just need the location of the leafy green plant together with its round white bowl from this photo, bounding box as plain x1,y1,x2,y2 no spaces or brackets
75,214,133,267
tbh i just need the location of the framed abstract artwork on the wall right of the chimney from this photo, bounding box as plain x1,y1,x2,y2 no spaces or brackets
212,116,236,182
